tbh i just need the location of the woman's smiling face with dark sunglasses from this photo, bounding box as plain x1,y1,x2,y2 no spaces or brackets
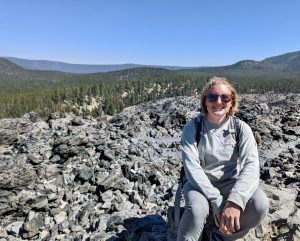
205,84,232,120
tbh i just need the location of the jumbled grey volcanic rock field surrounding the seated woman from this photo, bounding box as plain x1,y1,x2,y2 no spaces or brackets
0,93,300,241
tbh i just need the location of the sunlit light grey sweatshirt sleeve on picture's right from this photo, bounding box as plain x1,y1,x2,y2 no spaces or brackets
227,121,259,210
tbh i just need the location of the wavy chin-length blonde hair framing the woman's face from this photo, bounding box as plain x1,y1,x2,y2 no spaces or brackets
200,76,240,116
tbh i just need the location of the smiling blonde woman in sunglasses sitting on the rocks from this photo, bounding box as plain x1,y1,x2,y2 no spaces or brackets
177,77,269,241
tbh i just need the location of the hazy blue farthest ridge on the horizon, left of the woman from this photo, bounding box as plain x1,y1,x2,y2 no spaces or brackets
3,57,195,74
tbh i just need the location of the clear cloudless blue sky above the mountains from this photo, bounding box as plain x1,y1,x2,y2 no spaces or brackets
0,0,300,66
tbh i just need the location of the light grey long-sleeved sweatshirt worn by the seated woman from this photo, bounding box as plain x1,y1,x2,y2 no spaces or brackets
181,114,259,215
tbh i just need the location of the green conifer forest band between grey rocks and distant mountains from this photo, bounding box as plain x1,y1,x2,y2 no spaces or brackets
0,54,300,118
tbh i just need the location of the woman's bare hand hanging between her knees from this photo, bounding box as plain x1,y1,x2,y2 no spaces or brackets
218,201,241,234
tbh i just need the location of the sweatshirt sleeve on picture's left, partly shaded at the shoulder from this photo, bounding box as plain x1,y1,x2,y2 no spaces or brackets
181,119,223,215
